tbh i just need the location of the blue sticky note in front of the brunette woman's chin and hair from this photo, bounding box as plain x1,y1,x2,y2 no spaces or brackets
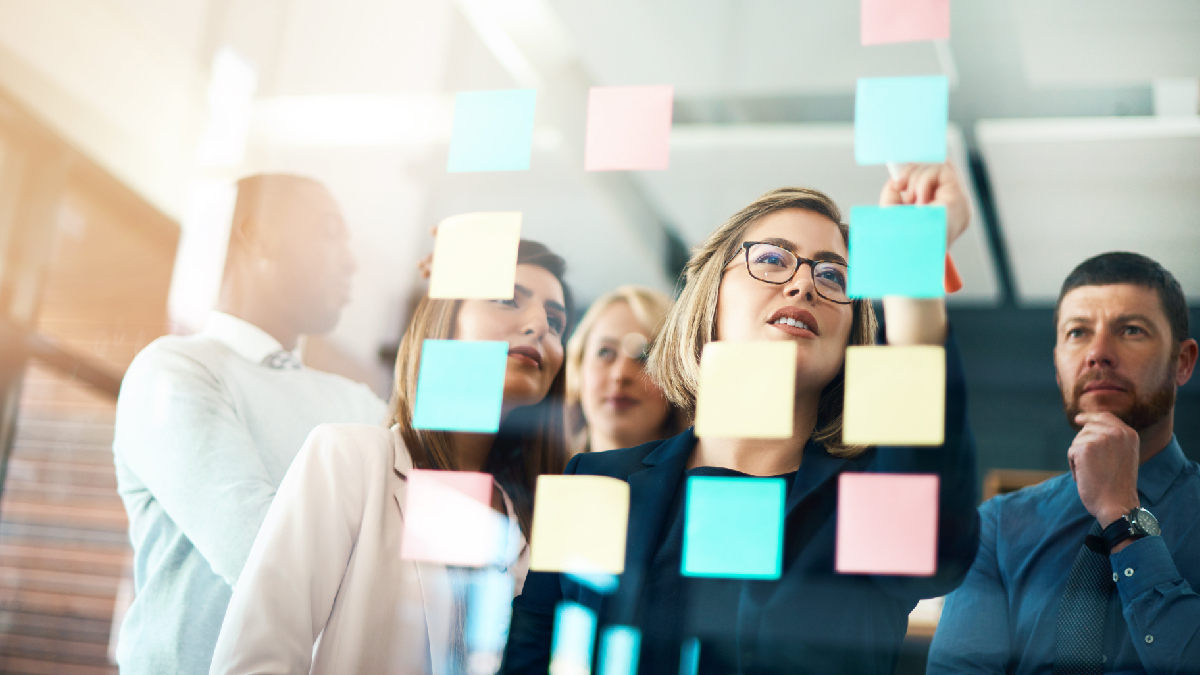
413,340,509,434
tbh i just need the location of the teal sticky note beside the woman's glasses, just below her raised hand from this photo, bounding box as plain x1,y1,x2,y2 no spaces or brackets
847,207,946,298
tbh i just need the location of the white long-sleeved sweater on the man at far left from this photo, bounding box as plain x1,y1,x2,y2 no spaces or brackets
113,313,386,674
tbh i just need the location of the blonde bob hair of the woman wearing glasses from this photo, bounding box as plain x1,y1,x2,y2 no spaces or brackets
648,187,878,458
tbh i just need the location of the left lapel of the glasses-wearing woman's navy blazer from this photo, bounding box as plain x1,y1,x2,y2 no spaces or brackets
613,429,696,625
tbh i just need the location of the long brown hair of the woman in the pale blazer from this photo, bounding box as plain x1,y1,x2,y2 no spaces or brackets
388,239,575,538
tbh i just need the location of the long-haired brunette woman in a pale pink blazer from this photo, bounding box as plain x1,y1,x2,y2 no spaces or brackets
211,240,572,675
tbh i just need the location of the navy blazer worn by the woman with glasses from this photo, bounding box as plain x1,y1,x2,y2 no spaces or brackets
500,339,979,675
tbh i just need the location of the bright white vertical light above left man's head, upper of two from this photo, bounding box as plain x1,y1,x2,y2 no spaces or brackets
197,47,258,168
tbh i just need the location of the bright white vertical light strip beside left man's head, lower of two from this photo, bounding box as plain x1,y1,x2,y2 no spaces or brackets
167,180,238,333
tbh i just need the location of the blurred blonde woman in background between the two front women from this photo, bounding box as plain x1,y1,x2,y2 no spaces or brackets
565,286,686,454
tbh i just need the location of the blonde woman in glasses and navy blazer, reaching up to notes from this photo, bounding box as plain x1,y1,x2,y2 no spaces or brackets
502,165,978,675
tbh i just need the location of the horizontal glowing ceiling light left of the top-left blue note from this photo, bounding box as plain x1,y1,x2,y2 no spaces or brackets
254,94,454,148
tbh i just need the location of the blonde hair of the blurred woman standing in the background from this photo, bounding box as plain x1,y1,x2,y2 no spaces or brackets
564,285,688,453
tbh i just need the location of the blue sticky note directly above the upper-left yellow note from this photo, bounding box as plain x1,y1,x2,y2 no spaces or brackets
446,89,538,173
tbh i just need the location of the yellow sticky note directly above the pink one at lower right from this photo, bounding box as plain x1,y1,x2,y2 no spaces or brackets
841,345,946,446
